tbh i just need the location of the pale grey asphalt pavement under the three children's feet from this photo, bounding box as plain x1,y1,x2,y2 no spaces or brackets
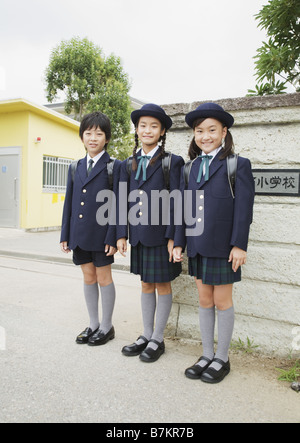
0,228,300,426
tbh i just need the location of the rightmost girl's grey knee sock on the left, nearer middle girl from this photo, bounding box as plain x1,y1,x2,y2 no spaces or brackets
197,306,216,367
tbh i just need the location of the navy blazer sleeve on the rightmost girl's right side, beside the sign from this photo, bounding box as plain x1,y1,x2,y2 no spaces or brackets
231,158,255,251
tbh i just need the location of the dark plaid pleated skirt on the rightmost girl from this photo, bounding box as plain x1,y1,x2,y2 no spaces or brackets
189,254,242,285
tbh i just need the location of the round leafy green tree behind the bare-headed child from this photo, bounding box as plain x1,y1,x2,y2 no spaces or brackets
45,37,132,159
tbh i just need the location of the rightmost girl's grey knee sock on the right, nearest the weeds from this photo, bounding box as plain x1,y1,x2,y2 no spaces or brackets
211,306,234,370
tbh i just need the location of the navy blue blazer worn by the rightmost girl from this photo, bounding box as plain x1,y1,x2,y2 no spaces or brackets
174,151,255,258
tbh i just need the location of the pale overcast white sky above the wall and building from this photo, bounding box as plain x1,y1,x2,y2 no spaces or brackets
0,0,269,105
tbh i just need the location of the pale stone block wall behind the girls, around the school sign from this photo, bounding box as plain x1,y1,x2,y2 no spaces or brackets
163,93,300,355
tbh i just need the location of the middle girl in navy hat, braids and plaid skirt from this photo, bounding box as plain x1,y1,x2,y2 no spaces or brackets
117,104,184,362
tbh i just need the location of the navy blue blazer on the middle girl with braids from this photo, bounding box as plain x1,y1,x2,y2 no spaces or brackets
117,148,184,246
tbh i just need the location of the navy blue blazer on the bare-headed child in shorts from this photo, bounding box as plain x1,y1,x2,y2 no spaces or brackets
60,152,121,252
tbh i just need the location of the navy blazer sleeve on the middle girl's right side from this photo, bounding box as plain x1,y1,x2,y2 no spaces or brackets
165,154,184,240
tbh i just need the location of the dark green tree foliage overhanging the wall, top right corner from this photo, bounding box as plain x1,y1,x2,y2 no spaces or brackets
248,0,300,95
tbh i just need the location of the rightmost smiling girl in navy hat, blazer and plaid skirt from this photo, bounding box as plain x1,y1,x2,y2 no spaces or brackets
174,103,254,383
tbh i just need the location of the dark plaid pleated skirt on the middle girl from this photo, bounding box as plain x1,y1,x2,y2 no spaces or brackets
130,243,182,283
